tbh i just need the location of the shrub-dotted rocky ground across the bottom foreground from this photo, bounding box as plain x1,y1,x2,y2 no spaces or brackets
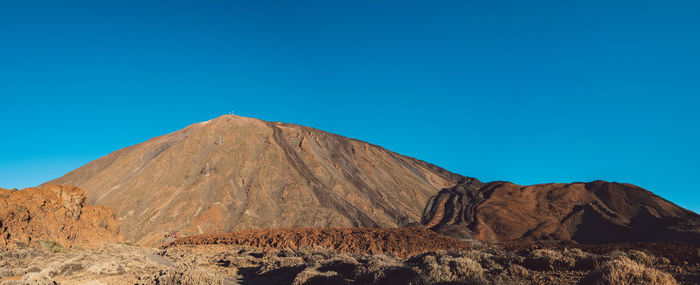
0,237,700,285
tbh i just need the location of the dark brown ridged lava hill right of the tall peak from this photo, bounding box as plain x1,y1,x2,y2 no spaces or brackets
423,179,700,243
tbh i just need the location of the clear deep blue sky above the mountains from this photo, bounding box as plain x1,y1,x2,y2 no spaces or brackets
0,0,700,212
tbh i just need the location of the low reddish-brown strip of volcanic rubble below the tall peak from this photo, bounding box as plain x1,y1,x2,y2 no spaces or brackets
166,228,467,257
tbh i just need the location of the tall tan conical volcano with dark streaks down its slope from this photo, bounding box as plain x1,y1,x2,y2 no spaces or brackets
47,115,462,244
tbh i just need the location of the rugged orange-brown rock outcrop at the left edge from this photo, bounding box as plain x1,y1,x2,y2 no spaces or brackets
0,186,122,247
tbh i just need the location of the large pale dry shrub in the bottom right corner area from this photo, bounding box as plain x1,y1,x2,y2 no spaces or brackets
581,256,678,285
